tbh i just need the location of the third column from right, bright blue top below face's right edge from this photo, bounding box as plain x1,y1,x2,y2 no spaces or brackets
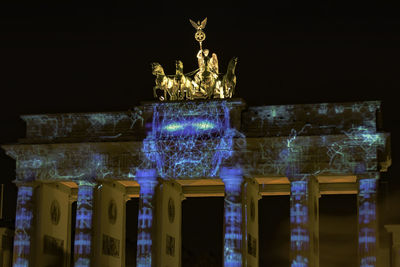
220,168,243,267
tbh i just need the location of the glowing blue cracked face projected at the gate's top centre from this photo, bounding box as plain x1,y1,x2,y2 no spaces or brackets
142,101,235,178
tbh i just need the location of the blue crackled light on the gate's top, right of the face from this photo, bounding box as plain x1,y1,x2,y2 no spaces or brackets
247,101,387,179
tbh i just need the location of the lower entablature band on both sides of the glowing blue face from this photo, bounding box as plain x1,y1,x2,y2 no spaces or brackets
3,133,390,181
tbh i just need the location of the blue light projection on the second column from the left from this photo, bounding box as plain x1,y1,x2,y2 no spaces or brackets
74,181,95,267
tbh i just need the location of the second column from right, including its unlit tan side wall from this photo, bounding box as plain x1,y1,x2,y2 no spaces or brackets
289,175,319,267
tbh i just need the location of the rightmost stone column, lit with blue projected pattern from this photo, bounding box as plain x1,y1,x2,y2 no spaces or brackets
358,173,379,267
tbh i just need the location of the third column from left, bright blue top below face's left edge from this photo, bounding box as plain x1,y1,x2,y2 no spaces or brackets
136,169,158,267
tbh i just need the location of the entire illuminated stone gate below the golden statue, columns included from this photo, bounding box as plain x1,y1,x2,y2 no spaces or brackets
3,99,390,267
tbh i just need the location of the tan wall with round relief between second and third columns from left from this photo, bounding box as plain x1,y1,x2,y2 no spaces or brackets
93,182,126,267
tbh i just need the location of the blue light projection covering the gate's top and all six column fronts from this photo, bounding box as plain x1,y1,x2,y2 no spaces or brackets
6,100,390,267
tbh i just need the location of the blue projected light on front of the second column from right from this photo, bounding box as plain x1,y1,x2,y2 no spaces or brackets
290,181,310,267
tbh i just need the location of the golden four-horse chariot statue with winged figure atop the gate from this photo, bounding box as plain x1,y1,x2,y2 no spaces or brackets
152,18,237,101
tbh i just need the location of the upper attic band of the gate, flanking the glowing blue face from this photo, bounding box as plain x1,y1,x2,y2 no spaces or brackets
20,99,381,143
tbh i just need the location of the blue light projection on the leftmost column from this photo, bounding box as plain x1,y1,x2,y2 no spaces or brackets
13,186,33,267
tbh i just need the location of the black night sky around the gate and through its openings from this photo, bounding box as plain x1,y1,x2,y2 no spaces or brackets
0,0,400,267
